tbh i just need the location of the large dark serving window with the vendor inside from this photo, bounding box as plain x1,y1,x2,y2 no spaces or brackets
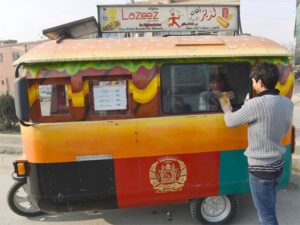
161,63,250,114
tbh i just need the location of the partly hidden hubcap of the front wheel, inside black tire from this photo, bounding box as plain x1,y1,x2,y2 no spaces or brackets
14,184,40,213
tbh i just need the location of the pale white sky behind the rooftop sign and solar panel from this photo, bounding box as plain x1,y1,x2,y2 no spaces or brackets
0,0,296,47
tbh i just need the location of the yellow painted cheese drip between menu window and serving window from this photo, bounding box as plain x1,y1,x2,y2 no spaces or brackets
129,75,159,104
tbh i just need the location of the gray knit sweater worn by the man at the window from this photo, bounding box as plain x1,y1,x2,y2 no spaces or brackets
224,95,293,165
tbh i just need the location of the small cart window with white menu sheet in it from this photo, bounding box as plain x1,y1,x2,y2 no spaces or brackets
90,80,128,116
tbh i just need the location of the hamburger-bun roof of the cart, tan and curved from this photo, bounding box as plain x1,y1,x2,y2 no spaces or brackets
15,36,291,64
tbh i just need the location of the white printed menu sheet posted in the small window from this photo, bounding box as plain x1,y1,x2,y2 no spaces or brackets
93,81,127,111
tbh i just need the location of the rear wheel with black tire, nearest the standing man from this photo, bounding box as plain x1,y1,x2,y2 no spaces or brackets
190,195,236,224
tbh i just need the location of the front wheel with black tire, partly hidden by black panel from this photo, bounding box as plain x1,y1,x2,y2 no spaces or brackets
7,179,44,217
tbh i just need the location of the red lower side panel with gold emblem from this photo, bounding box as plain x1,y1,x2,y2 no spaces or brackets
115,152,219,208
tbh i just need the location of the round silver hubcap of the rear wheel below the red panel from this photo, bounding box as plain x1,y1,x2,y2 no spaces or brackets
201,196,231,222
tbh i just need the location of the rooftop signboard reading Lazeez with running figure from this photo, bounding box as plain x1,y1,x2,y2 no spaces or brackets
98,5,239,32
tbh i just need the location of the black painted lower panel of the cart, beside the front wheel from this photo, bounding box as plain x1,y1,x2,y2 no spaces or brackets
28,160,117,213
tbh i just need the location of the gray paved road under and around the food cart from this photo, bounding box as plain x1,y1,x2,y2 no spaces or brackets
0,154,300,225
